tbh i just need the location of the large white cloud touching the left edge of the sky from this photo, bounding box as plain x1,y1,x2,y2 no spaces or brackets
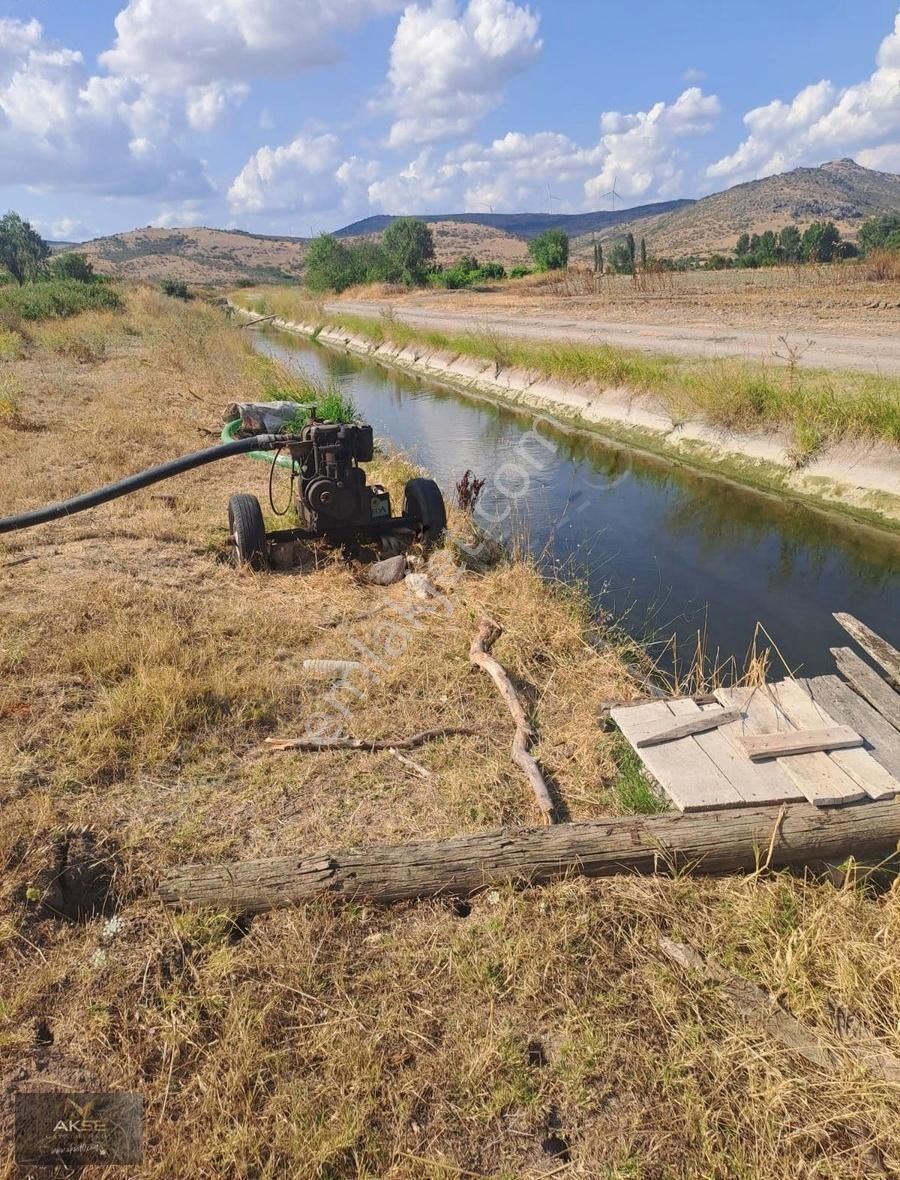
0,20,210,196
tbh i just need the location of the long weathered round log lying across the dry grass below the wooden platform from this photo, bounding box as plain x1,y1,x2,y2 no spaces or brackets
159,800,900,913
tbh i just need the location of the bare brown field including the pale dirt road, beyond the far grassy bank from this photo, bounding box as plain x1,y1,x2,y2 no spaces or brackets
334,267,900,373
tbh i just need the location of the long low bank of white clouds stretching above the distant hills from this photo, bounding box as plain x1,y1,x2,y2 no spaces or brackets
229,89,718,219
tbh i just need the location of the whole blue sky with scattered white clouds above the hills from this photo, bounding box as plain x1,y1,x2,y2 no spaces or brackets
0,0,900,238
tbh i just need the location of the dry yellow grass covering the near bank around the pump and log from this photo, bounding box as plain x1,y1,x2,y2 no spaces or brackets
0,293,900,1180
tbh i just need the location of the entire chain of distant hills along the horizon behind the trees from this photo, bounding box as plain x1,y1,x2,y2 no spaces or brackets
53,159,900,284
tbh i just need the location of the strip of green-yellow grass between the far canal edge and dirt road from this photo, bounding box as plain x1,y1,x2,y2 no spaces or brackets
234,288,900,463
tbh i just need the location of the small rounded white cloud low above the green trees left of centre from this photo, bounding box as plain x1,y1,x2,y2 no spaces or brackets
228,133,347,214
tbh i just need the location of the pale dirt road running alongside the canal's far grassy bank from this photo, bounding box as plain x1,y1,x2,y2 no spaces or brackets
326,300,900,373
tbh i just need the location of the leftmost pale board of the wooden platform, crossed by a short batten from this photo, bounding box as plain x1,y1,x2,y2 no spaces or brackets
612,701,743,812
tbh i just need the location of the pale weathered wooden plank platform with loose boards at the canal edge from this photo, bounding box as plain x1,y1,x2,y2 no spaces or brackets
611,615,900,812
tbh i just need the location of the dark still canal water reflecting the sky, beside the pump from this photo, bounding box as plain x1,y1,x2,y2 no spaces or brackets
255,330,900,675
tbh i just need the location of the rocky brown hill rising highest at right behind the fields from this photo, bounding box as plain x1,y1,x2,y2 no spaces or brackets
572,159,900,258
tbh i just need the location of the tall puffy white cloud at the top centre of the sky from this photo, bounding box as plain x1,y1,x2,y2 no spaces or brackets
388,0,543,148
